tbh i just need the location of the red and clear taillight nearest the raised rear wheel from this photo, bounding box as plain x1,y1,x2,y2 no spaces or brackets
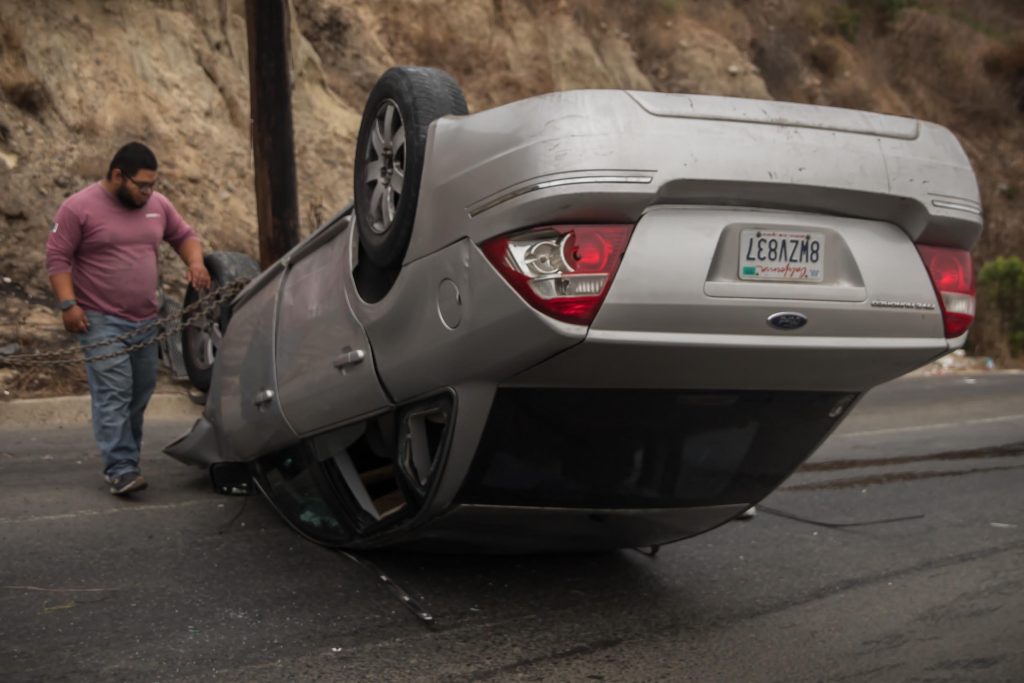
480,225,633,325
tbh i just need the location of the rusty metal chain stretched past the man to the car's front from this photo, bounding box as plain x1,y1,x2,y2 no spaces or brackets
0,280,249,368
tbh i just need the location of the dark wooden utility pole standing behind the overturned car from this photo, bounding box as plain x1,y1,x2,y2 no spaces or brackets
246,0,299,268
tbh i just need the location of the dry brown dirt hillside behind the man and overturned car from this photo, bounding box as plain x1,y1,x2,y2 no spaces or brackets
0,0,1024,395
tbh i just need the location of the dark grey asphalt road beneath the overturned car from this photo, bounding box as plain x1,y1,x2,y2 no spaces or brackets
0,374,1024,683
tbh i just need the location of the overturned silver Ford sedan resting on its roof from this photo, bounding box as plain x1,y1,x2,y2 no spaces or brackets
167,68,982,551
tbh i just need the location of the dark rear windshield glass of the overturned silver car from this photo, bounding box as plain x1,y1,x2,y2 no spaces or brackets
459,388,856,508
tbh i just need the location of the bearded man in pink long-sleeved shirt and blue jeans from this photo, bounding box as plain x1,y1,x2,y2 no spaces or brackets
46,142,210,496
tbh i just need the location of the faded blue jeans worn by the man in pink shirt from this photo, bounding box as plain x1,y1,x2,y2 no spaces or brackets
79,311,159,477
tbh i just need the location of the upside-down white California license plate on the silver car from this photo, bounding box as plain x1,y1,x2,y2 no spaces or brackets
739,228,825,283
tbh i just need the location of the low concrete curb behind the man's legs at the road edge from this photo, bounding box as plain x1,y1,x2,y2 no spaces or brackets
0,391,203,429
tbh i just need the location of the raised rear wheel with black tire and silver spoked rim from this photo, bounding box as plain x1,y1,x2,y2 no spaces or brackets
353,67,469,270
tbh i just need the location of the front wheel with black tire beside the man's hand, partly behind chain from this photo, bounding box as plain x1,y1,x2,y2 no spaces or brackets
181,252,259,391
